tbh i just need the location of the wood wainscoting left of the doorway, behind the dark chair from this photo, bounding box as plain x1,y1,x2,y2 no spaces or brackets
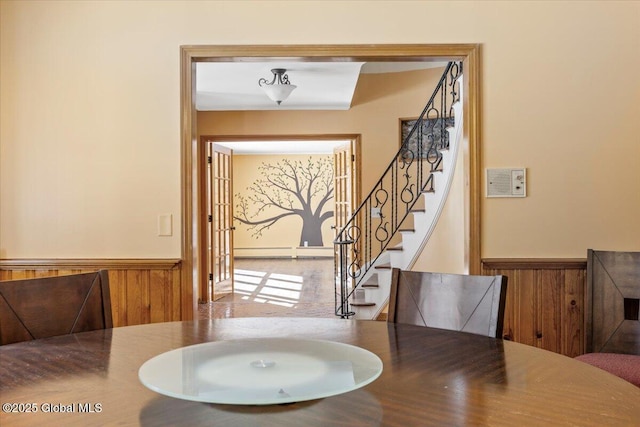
0,259,182,327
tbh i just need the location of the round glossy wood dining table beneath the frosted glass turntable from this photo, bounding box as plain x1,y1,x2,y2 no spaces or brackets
0,318,640,427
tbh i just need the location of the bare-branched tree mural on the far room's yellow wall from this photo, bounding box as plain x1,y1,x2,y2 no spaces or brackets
234,156,333,246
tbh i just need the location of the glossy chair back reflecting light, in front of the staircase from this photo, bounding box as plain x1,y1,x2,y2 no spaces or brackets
387,268,507,338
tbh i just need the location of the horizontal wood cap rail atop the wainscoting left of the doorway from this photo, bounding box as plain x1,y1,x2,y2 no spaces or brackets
0,258,181,270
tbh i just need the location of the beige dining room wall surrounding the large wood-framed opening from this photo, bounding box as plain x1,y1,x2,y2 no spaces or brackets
0,0,640,258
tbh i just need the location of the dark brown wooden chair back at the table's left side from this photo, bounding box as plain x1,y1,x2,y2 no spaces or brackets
0,270,113,345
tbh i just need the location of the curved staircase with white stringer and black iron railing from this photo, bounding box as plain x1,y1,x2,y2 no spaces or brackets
334,62,463,319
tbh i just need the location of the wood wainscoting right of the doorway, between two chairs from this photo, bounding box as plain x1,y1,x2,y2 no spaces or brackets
482,259,587,357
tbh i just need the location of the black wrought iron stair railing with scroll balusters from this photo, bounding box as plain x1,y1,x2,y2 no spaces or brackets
334,62,462,317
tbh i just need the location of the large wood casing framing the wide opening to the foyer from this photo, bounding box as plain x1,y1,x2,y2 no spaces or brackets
180,43,482,313
